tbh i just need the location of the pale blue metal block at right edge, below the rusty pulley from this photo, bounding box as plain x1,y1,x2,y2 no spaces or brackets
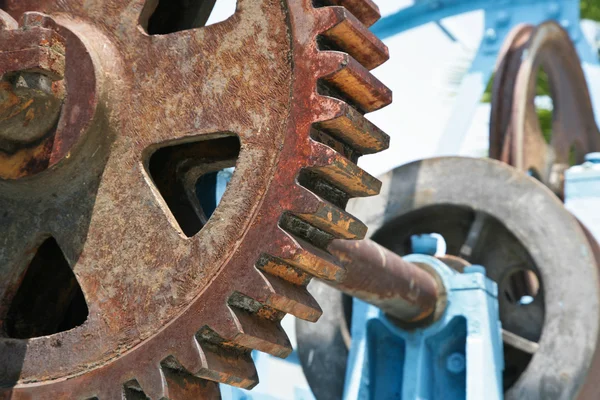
565,153,600,242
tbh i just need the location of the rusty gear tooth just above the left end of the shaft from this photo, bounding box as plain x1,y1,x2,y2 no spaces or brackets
291,187,367,239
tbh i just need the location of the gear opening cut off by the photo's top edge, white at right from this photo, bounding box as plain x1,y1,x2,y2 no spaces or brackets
147,0,237,35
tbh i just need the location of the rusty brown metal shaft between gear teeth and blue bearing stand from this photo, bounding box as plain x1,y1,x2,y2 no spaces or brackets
327,239,444,322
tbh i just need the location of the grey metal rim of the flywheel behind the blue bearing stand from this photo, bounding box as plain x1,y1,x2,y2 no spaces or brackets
350,157,600,399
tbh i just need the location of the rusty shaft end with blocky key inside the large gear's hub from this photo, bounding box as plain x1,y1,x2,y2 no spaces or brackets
0,13,66,179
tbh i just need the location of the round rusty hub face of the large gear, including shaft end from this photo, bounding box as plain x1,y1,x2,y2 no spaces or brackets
0,8,97,179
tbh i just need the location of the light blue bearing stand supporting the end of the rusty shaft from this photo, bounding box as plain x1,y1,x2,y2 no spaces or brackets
344,255,504,400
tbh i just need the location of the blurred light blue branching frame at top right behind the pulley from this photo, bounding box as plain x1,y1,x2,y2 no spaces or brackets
371,0,599,155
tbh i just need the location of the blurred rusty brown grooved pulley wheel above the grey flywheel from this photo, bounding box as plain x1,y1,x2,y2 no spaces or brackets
490,21,600,198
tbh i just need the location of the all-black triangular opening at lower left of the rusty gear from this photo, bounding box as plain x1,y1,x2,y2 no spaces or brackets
5,238,88,339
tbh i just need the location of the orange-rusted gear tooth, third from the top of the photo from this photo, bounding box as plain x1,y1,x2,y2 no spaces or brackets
318,52,392,113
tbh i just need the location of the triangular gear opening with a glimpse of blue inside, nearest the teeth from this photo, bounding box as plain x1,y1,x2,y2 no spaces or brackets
148,134,240,237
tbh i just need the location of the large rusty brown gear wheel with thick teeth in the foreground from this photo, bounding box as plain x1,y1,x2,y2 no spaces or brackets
0,0,391,400
